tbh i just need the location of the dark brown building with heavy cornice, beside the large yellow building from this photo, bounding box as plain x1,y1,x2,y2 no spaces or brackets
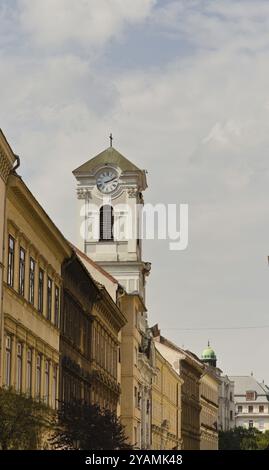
60,253,126,412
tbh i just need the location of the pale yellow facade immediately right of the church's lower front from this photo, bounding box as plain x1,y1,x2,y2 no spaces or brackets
152,342,183,450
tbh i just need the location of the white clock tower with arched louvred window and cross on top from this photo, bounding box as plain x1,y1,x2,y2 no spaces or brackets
73,140,150,300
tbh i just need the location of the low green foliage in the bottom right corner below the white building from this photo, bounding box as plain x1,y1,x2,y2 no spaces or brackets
219,427,269,450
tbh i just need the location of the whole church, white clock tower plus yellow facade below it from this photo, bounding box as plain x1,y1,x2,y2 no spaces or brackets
73,136,155,449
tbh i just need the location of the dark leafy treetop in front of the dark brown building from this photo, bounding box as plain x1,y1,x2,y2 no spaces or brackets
50,401,130,450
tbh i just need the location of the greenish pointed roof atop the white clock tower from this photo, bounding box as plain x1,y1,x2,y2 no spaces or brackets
73,147,142,175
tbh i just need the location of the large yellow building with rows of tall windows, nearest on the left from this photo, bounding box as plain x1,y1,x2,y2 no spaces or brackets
0,173,72,408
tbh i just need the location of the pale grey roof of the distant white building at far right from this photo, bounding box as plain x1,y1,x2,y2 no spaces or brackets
229,375,269,402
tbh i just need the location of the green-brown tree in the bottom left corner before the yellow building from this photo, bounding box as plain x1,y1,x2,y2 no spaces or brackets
0,388,49,450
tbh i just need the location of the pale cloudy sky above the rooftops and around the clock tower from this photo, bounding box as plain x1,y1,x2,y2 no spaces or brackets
0,0,269,383
